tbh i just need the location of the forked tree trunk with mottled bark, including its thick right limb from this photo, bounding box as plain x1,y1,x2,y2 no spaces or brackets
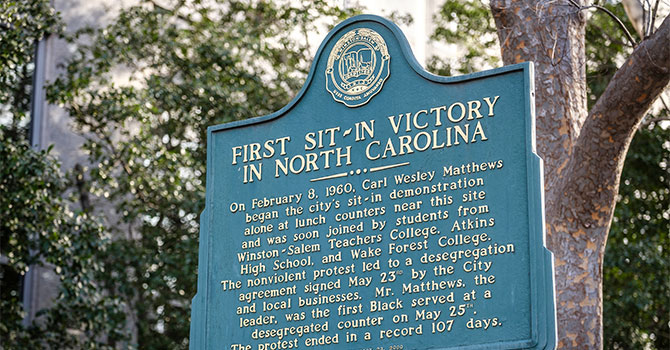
491,0,670,349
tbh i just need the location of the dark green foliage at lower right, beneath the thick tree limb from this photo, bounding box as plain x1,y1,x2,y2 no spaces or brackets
603,121,670,349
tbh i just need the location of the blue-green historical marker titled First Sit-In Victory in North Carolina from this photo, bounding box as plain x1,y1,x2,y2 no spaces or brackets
191,16,556,350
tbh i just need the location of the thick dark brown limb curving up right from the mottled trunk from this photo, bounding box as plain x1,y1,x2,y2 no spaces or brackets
559,17,670,231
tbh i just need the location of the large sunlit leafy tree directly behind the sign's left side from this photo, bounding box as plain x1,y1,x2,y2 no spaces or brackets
49,0,360,349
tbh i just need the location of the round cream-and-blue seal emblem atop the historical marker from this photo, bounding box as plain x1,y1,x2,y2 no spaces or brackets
326,28,391,107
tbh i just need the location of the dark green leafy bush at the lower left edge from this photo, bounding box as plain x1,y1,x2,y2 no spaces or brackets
0,126,129,349
